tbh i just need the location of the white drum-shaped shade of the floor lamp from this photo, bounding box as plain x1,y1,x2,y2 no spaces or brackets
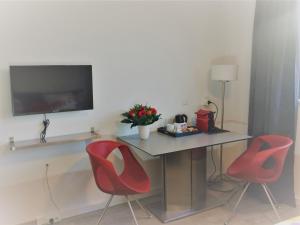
211,65,238,81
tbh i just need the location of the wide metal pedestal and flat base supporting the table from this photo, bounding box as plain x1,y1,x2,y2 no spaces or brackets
144,148,224,223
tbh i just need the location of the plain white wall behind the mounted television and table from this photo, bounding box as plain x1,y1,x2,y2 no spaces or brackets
0,1,255,225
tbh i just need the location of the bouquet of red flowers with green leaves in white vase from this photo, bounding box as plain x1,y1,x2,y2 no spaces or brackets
121,104,161,127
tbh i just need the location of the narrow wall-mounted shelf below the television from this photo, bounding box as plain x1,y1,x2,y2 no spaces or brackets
9,132,100,151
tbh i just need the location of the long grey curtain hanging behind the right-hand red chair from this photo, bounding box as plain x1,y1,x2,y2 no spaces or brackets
249,0,299,206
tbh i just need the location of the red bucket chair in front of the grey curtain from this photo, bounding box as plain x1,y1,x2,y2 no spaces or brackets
225,135,293,224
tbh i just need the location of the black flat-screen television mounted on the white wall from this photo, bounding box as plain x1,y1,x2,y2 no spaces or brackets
10,65,93,116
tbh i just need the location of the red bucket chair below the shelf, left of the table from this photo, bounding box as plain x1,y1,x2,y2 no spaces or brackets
87,141,151,225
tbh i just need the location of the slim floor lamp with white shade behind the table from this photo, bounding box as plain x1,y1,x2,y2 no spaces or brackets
211,65,238,180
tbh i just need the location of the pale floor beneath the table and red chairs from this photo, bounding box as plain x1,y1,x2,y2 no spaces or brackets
38,196,300,225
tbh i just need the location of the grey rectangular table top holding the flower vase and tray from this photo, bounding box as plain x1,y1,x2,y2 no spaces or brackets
118,132,251,156
